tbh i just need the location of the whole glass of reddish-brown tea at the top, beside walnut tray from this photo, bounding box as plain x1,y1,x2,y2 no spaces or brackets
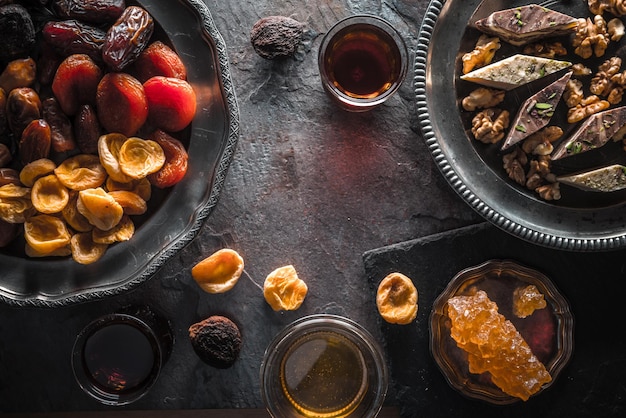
318,15,408,112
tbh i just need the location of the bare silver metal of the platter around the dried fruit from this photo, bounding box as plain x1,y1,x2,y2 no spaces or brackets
0,0,239,307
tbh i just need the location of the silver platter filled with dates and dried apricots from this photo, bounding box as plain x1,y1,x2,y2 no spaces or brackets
0,0,239,307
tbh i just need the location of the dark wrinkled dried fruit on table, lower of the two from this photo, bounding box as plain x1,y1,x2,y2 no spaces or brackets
189,315,241,369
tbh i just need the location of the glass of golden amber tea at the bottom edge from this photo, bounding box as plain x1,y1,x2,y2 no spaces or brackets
261,314,388,418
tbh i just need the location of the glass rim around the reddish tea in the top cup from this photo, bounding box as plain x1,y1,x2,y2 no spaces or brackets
317,13,409,111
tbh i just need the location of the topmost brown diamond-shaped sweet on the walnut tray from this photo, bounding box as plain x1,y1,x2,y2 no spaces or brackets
475,4,577,46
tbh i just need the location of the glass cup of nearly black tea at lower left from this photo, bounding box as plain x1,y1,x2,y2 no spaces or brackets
71,307,173,406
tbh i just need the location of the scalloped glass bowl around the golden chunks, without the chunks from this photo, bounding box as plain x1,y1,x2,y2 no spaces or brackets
430,260,574,405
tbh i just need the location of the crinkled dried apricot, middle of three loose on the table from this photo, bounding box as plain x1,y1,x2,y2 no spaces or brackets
263,265,308,311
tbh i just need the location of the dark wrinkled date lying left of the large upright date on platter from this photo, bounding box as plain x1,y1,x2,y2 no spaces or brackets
41,19,106,61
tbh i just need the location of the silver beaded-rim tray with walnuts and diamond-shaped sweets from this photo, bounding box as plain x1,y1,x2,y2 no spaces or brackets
415,0,626,251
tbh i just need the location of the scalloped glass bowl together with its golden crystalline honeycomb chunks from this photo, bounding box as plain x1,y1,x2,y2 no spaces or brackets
430,260,574,405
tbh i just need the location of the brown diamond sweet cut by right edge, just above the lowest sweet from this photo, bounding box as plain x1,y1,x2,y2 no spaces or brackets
552,106,626,160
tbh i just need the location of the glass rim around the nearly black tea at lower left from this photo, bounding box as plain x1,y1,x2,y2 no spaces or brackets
71,312,164,406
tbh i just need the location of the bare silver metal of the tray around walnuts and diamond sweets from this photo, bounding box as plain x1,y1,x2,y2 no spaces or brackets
415,0,626,251
